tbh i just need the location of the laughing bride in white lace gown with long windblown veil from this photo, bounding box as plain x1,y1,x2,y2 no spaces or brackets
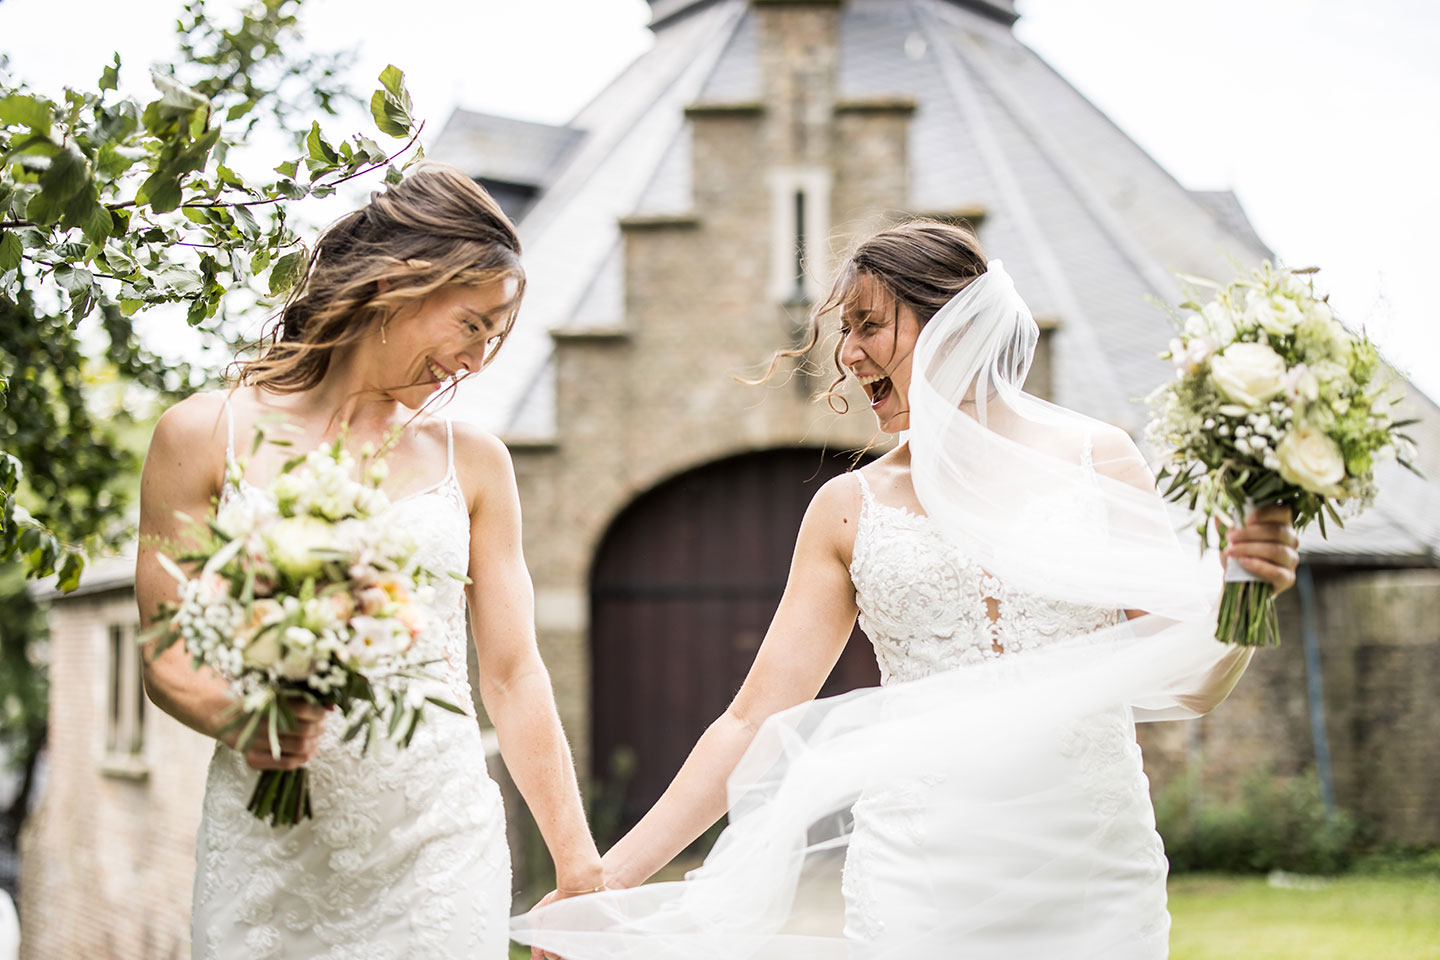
511,220,1297,960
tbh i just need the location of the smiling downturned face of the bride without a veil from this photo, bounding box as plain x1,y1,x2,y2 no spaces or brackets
376,276,520,410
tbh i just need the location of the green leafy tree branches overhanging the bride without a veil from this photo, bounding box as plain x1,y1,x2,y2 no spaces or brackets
0,0,423,587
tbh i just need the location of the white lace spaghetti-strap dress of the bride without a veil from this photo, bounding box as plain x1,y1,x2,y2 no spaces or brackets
192,417,510,960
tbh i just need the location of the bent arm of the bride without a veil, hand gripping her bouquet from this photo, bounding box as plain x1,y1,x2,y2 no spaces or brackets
135,394,324,770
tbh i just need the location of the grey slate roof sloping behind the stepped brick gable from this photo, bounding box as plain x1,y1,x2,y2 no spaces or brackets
431,0,1440,563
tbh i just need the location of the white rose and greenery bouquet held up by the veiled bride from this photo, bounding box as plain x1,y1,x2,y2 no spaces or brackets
1149,263,1418,646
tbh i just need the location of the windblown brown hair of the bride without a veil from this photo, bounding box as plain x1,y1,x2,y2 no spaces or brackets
233,163,526,393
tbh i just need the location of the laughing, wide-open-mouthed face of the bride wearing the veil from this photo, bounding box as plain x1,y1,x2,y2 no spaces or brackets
840,273,920,433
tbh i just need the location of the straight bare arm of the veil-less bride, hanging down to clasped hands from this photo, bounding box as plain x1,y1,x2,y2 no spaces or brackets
455,425,603,892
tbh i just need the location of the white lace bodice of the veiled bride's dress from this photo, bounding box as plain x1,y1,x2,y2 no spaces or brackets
850,474,1123,684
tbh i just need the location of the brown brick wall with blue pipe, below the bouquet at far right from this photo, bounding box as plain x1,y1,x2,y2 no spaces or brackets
1140,570,1440,846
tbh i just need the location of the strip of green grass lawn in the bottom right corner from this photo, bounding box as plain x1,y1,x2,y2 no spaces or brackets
1169,874,1440,960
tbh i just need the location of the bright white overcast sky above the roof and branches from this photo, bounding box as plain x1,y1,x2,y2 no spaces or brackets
0,0,1440,397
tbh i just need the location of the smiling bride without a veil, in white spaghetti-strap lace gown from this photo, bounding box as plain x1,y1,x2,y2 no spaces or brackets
135,166,602,960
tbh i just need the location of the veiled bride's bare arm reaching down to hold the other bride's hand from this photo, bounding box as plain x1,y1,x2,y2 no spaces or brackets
605,476,858,887
